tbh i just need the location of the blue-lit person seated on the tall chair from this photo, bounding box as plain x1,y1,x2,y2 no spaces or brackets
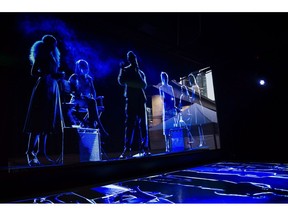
68,59,108,136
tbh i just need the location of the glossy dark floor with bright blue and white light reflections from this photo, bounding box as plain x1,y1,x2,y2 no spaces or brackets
16,162,288,204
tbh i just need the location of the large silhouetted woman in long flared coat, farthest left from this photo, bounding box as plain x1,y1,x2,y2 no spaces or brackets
24,35,64,166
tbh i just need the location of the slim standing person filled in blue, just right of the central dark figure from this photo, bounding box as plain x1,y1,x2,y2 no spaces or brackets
159,72,177,152
